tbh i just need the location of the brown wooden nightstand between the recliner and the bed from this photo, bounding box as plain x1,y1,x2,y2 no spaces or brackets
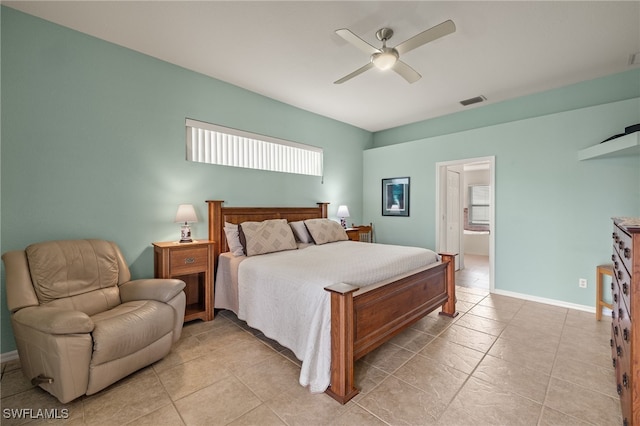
153,240,215,322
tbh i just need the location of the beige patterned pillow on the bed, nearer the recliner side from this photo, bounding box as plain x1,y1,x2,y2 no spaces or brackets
240,219,297,256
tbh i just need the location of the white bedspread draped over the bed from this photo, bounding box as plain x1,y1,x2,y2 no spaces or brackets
237,241,439,392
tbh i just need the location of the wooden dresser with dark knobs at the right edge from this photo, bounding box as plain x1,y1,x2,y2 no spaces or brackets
611,218,640,426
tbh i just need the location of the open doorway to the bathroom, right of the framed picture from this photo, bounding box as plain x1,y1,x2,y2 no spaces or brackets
436,156,496,291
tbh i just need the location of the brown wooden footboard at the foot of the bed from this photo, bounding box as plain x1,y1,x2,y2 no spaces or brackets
326,254,457,404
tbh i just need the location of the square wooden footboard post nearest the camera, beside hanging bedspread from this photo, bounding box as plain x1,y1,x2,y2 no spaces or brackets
325,283,359,404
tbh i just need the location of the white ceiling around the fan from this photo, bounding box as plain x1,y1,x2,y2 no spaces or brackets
3,1,640,131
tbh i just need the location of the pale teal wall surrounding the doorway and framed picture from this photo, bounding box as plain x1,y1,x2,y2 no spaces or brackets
363,98,640,306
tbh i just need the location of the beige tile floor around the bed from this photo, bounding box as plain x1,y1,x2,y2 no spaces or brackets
1,258,622,426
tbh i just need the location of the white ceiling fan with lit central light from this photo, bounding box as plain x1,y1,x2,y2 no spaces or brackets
333,20,456,84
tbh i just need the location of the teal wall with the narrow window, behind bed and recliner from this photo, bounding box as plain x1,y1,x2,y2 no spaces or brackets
0,7,372,353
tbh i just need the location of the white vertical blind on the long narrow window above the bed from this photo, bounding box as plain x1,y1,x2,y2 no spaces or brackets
185,119,323,176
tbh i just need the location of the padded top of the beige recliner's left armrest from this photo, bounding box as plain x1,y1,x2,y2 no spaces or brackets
13,306,94,334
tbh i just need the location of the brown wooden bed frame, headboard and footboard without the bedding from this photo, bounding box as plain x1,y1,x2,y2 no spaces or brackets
207,200,457,404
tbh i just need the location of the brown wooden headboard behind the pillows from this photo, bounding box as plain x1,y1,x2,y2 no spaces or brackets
207,200,329,263
